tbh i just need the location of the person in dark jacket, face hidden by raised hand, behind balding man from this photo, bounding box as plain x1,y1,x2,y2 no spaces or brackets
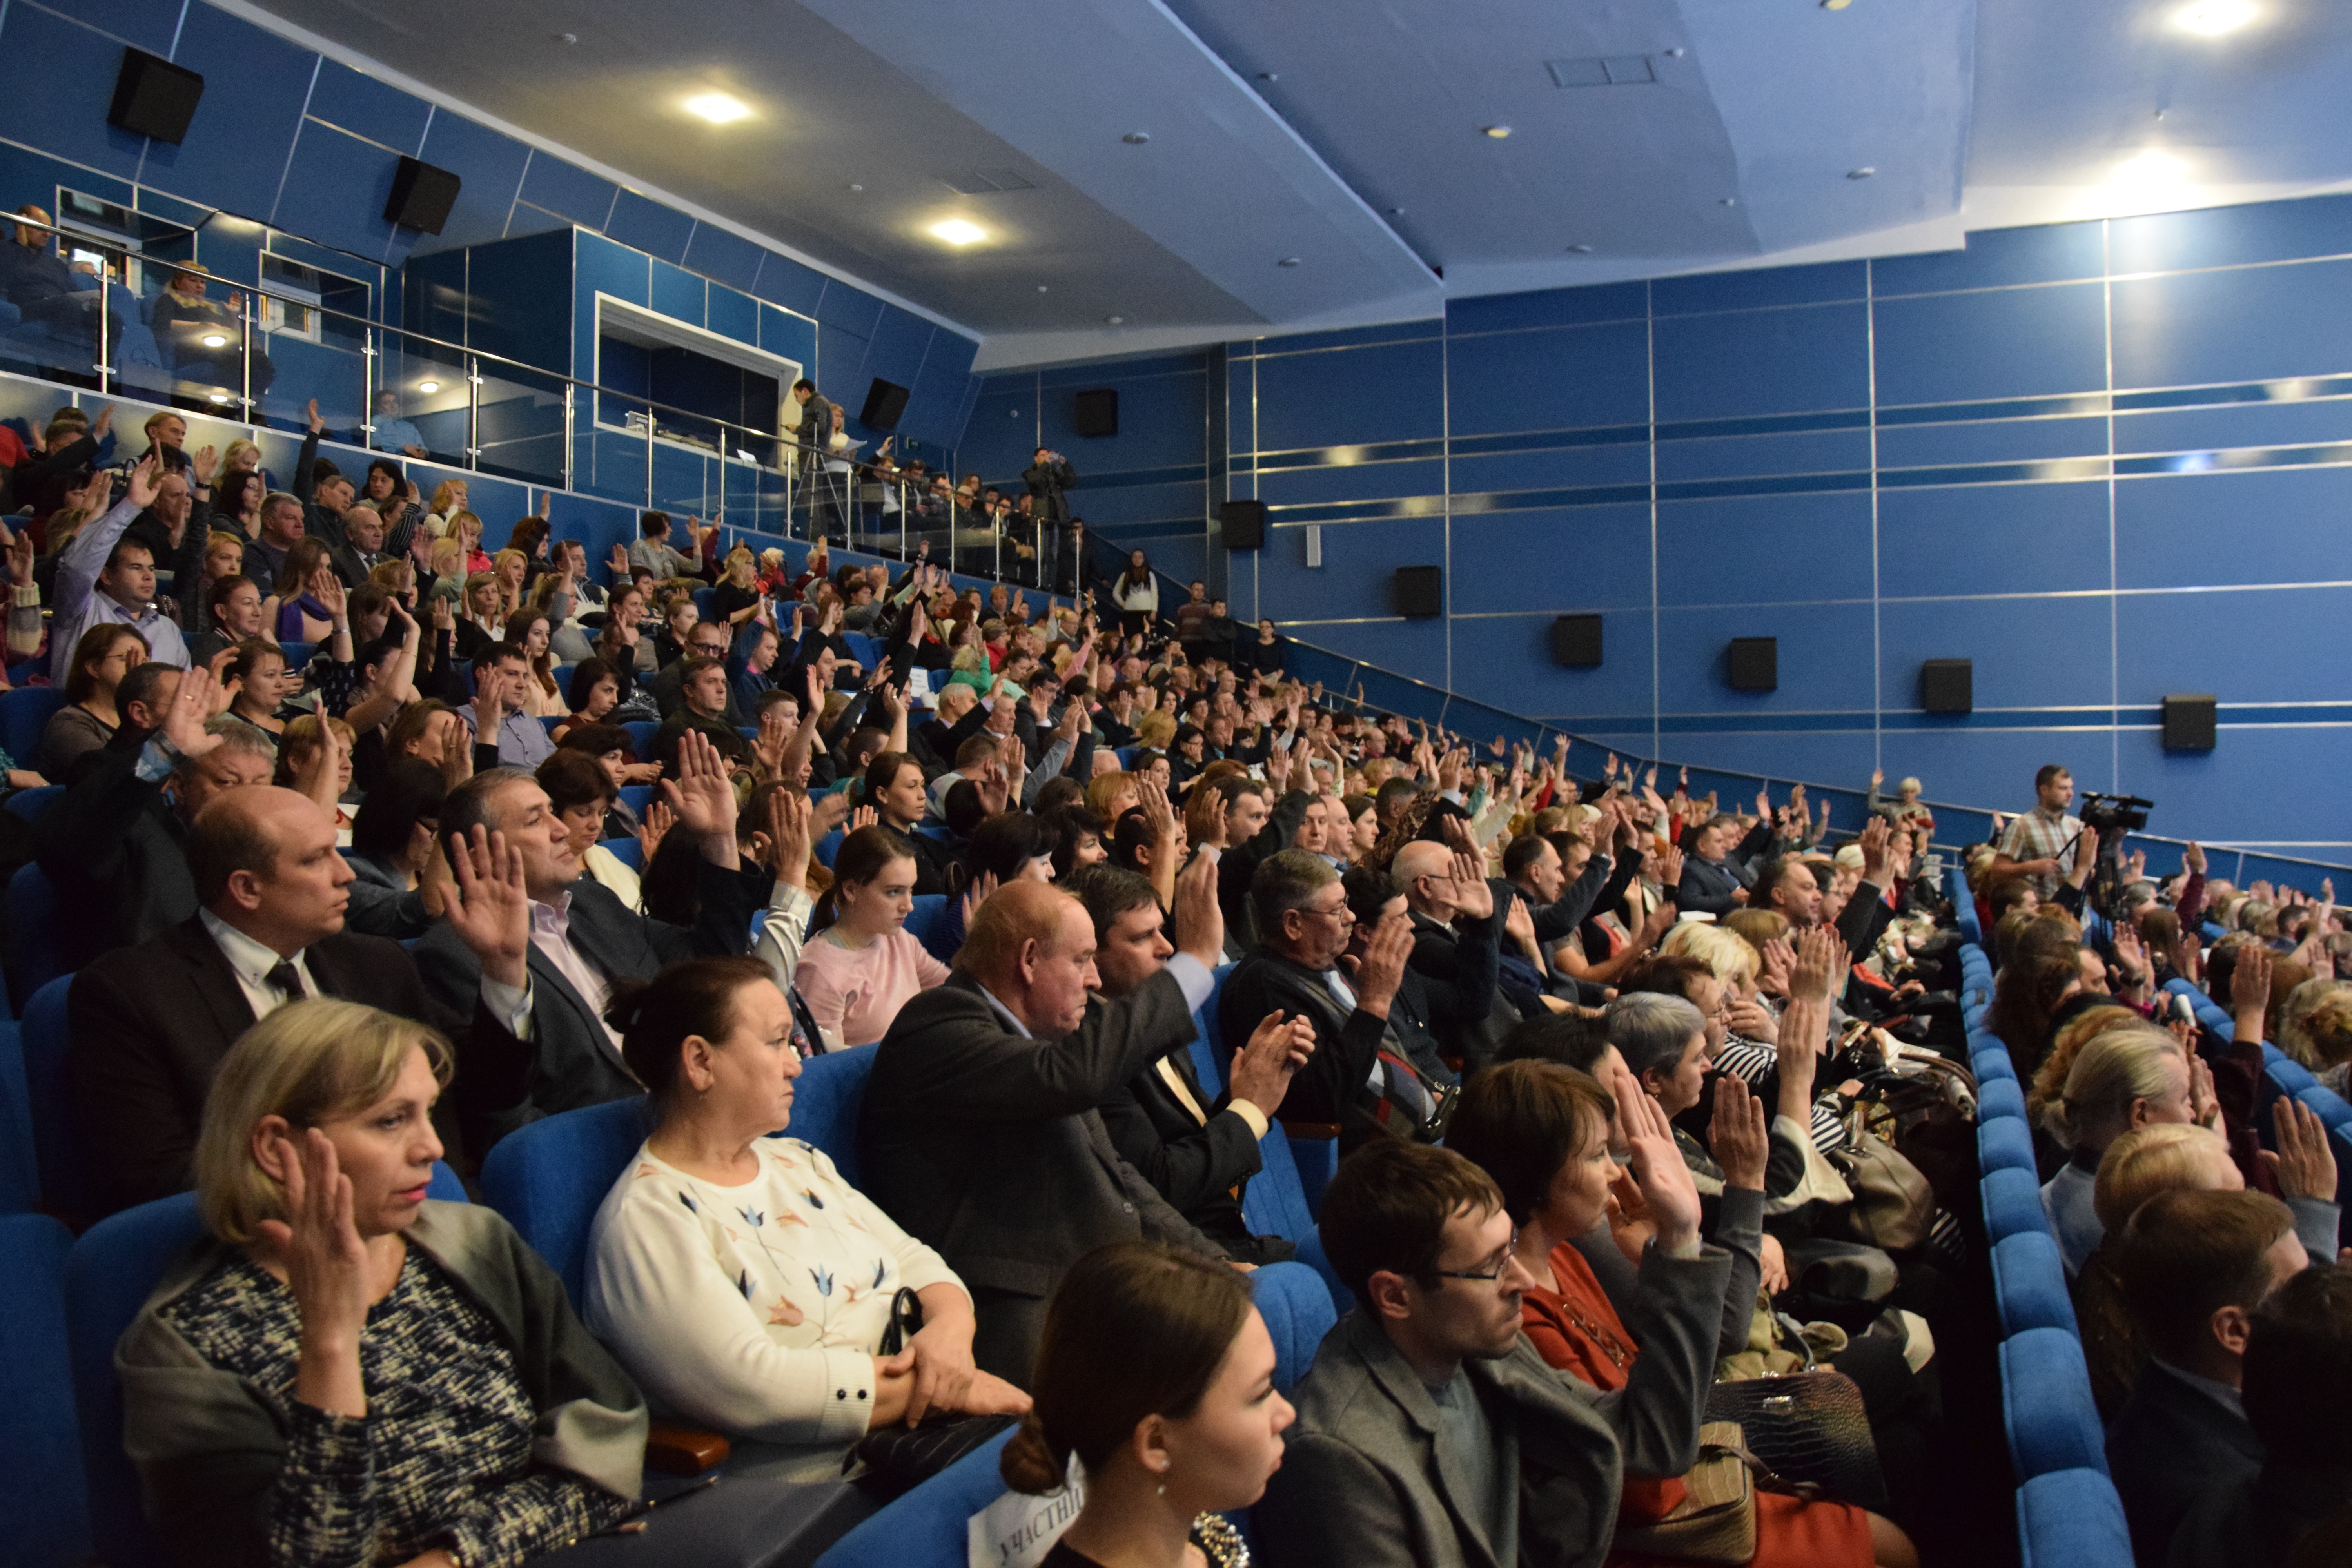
40,663,278,969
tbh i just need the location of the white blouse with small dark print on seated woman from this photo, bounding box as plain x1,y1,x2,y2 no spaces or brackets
583,1138,962,1443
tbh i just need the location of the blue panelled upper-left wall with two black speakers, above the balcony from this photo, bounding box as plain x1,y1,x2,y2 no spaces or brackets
0,0,978,454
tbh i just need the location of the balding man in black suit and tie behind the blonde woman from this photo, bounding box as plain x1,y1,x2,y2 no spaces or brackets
66,785,437,1218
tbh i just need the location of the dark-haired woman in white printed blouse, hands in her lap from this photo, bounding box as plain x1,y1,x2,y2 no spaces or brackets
581,957,1028,1443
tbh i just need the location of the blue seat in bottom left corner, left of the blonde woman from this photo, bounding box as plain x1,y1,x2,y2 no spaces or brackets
0,1213,89,1568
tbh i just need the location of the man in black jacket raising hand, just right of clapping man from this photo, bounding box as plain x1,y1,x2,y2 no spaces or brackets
1216,849,1454,1150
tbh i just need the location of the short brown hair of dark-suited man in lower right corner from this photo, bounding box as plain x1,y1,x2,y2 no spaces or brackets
2114,1192,2296,1361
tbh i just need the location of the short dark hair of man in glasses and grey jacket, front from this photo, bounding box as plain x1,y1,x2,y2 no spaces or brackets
1327,1142,1503,1312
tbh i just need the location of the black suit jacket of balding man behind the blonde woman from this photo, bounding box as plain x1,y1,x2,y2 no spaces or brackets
66,917,449,1218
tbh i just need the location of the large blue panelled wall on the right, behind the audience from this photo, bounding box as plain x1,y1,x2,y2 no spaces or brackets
969,198,2352,863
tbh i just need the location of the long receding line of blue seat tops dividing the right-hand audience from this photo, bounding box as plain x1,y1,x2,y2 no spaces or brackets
1957,882,2131,1568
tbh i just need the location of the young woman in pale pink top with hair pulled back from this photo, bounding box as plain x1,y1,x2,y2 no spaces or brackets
793,828,948,1051
